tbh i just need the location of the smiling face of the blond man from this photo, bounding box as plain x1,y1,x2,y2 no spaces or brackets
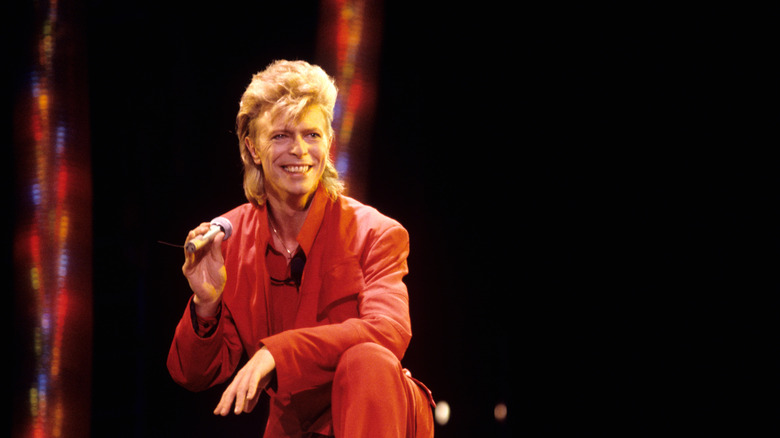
255,107,330,207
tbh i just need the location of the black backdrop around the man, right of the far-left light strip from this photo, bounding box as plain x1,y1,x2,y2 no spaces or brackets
7,0,779,437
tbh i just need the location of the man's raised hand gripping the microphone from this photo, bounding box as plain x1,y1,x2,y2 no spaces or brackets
181,222,227,318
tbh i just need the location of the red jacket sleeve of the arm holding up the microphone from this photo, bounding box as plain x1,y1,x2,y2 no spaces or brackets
168,298,243,391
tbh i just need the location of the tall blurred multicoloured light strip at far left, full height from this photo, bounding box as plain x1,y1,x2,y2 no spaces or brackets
13,0,92,438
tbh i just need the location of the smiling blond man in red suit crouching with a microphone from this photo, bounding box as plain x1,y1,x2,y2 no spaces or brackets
168,61,433,438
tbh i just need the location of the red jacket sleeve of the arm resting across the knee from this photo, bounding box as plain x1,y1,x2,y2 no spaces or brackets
261,225,412,393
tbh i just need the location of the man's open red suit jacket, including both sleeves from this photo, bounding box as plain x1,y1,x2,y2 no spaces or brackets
168,187,427,437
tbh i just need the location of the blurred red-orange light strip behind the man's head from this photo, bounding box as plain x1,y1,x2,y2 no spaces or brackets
318,0,382,198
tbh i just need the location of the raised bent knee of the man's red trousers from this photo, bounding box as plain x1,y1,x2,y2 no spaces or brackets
332,343,433,438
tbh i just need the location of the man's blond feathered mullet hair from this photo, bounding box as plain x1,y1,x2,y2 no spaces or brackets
236,60,344,207
